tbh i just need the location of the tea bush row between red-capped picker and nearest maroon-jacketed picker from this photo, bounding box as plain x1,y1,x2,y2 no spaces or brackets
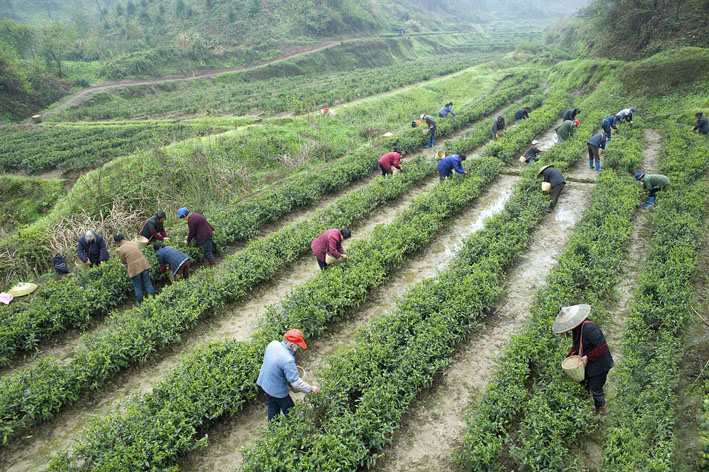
45,83,563,470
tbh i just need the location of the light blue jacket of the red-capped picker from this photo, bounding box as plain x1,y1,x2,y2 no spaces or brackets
256,341,300,398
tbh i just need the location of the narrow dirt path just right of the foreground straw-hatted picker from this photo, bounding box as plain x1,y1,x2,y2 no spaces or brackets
574,129,662,472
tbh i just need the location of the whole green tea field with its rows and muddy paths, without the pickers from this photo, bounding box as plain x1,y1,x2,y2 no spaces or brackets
0,25,709,472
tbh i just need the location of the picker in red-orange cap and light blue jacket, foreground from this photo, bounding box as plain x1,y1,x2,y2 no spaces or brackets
256,329,320,421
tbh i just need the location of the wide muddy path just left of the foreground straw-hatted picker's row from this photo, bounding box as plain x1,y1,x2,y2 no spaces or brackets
373,166,593,471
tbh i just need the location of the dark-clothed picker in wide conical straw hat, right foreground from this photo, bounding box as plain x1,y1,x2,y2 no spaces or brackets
552,304,613,415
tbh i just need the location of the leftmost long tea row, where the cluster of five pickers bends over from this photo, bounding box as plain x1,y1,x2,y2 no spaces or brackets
0,74,534,365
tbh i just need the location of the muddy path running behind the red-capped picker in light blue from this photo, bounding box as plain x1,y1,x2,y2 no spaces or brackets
180,172,517,472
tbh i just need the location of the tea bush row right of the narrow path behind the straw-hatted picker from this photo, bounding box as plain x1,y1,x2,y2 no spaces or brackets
602,123,709,471
